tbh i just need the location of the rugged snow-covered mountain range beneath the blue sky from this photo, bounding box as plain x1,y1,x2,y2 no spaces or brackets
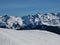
0,13,60,29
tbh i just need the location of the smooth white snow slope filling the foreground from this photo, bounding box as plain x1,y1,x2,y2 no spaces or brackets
0,28,60,45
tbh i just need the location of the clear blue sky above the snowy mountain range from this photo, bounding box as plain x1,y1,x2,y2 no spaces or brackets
0,0,60,16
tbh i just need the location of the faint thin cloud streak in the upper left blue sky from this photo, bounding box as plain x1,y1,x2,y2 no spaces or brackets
0,3,35,9
